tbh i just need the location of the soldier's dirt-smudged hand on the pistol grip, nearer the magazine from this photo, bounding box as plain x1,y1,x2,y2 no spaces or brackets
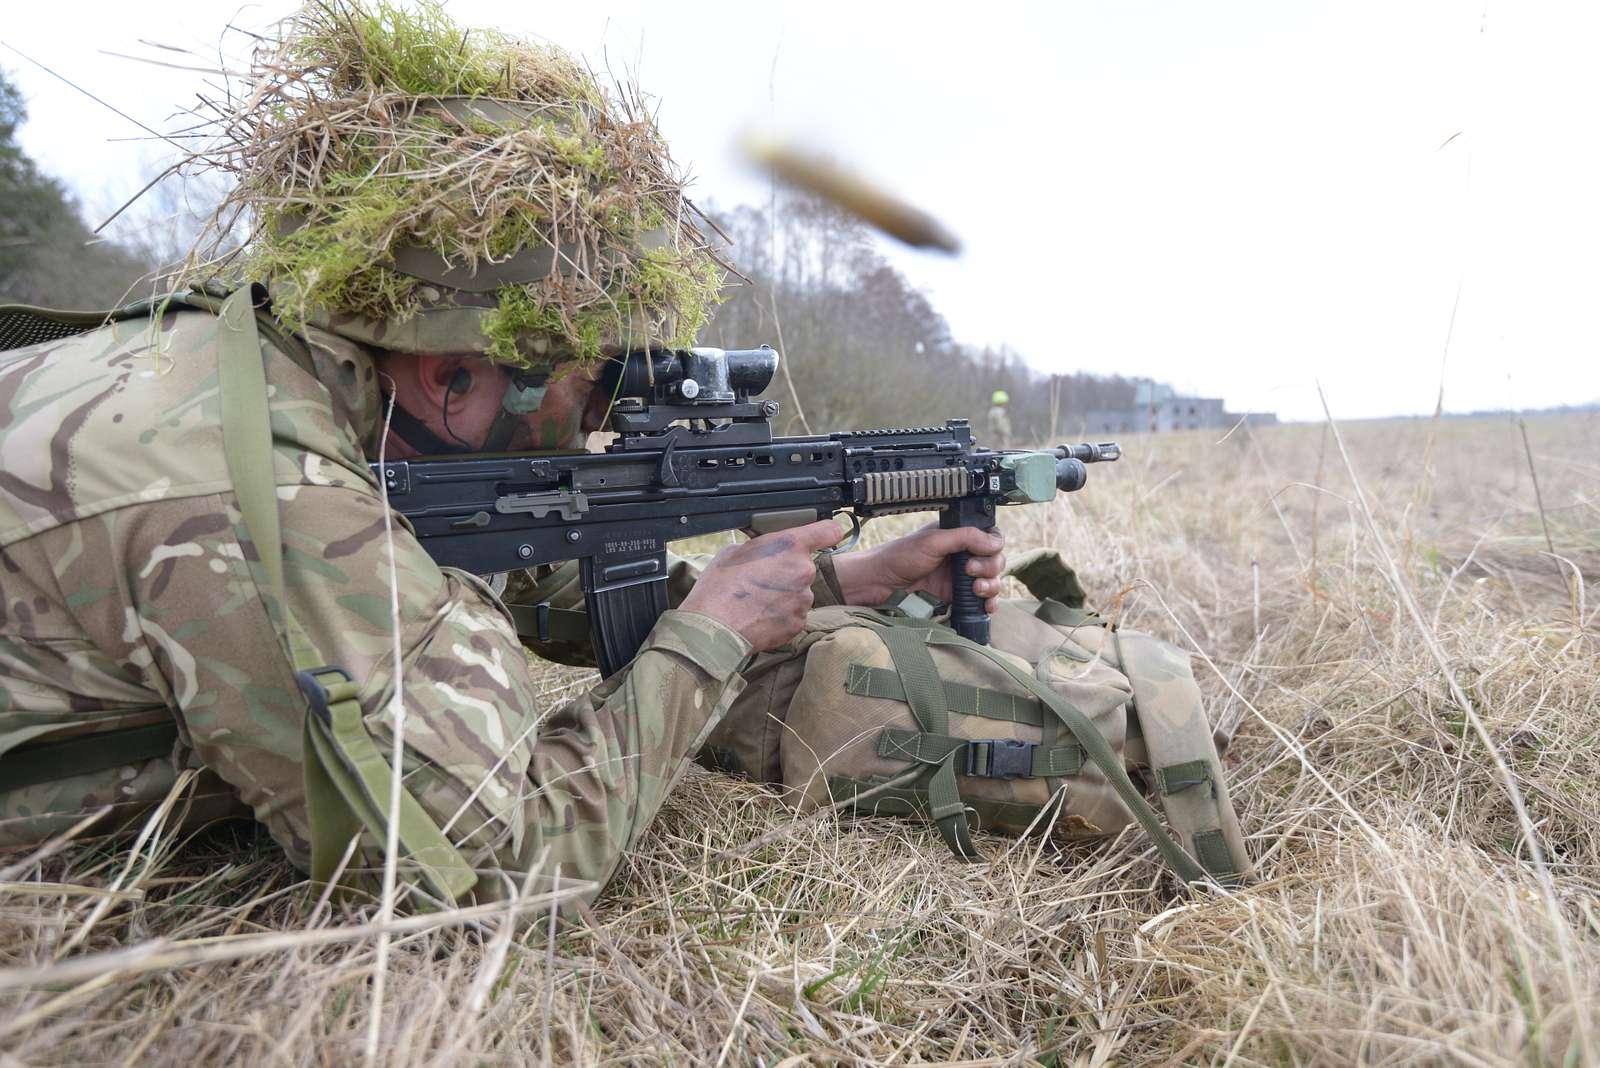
680,520,843,652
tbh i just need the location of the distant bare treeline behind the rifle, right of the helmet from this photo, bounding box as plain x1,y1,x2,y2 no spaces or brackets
701,197,1134,443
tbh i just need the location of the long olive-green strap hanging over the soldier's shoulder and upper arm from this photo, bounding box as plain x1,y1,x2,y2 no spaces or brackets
218,286,477,903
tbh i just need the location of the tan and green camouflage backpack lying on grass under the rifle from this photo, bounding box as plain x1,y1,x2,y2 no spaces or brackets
701,550,1253,884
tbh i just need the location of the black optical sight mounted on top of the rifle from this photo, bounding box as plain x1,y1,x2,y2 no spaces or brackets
600,345,778,404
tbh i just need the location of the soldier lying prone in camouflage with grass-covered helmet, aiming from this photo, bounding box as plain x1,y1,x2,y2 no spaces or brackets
0,5,1003,902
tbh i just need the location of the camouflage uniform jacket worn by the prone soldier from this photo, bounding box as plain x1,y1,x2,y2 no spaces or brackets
0,303,749,897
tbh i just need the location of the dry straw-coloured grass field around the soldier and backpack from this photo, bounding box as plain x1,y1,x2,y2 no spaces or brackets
0,406,1600,1065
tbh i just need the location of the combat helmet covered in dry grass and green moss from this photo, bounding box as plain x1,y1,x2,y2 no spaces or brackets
186,0,723,373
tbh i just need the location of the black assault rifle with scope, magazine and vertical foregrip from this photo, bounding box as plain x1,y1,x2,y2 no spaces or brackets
371,345,1122,675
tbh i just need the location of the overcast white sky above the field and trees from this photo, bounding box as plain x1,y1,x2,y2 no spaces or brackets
0,0,1600,419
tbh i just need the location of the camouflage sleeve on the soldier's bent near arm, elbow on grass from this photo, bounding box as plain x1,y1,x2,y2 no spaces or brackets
140,486,749,897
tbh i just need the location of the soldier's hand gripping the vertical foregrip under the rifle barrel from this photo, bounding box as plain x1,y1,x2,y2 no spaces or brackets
834,524,1005,612
